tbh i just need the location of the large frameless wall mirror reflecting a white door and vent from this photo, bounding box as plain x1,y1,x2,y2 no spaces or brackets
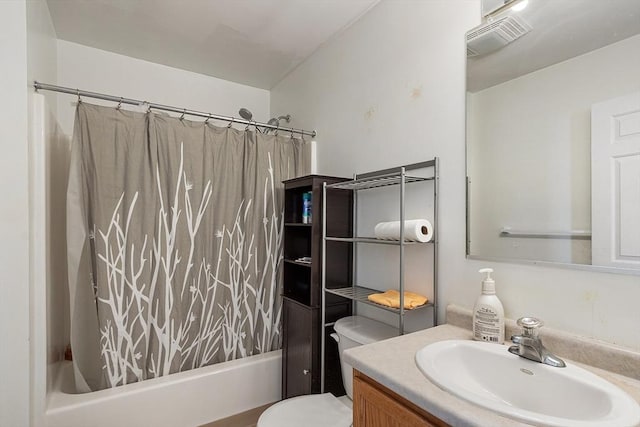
466,0,640,275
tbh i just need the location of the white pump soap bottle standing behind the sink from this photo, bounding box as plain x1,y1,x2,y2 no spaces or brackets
473,268,504,344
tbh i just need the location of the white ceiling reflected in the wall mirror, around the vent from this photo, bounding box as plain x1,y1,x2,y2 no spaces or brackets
467,0,640,92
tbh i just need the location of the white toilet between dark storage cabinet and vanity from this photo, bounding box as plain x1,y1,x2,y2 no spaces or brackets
257,316,398,427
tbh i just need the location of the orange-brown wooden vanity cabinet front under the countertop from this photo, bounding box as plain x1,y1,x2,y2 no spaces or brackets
353,370,449,427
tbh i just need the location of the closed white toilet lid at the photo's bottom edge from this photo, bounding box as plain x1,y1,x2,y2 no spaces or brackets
257,393,353,427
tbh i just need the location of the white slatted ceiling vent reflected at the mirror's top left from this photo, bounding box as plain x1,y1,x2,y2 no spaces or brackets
467,15,531,56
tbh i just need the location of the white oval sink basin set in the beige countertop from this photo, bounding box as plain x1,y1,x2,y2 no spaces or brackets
416,340,640,427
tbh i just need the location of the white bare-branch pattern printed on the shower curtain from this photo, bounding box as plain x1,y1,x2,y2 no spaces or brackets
90,144,283,387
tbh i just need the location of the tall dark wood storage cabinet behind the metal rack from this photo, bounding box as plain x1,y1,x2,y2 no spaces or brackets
282,175,353,399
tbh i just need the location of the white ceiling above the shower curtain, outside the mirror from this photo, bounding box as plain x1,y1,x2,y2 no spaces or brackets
47,0,379,89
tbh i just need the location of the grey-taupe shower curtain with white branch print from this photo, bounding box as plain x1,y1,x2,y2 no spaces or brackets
67,103,310,391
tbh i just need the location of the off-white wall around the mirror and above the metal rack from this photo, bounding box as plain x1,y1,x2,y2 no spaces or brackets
271,0,640,350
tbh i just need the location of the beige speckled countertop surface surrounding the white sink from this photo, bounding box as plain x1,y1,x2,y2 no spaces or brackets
343,314,640,427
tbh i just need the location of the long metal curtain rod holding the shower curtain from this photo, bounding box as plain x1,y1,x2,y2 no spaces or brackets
33,81,317,138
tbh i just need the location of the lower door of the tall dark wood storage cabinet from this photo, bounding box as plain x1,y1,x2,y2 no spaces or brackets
282,298,317,398
